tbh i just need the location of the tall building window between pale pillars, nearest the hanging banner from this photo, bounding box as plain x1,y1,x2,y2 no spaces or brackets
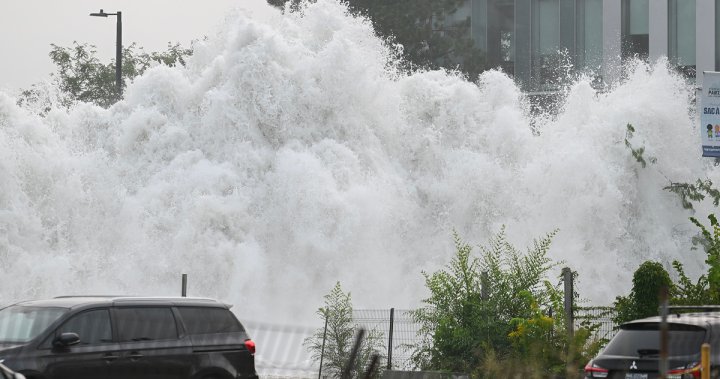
668,0,695,78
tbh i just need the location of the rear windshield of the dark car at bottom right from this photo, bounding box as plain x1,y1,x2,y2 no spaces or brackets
603,323,705,357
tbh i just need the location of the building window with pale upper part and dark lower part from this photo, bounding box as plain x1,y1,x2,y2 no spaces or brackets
621,0,648,63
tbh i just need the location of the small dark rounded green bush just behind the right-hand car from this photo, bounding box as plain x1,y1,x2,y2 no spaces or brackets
614,261,673,325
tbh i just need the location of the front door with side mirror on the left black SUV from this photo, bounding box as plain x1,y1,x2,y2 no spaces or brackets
38,308,119,379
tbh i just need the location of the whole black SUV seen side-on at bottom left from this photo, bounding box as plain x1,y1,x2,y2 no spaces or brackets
0,296,257,379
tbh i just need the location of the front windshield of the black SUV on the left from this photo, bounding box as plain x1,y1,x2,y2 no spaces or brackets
0,305,67,343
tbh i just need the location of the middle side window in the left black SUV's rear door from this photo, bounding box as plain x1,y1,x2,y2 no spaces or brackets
115,307,178,342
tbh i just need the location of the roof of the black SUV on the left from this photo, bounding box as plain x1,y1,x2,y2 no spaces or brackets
11,295,230,308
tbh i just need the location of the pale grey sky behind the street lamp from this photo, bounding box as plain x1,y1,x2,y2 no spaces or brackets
0,0,275,92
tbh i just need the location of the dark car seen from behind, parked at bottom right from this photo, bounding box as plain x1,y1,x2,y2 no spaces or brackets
585,312,720,379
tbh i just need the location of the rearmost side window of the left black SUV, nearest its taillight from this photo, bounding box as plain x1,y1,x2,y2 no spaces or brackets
178,307,244,334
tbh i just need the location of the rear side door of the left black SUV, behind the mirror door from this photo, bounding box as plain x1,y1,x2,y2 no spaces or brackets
113,306,193,379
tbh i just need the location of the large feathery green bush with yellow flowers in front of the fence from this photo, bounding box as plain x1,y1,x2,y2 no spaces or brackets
412,227,600,378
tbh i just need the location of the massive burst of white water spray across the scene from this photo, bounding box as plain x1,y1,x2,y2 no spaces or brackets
0,0,720,322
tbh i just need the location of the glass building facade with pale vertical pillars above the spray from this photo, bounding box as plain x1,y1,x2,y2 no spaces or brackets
461,0,720,91
